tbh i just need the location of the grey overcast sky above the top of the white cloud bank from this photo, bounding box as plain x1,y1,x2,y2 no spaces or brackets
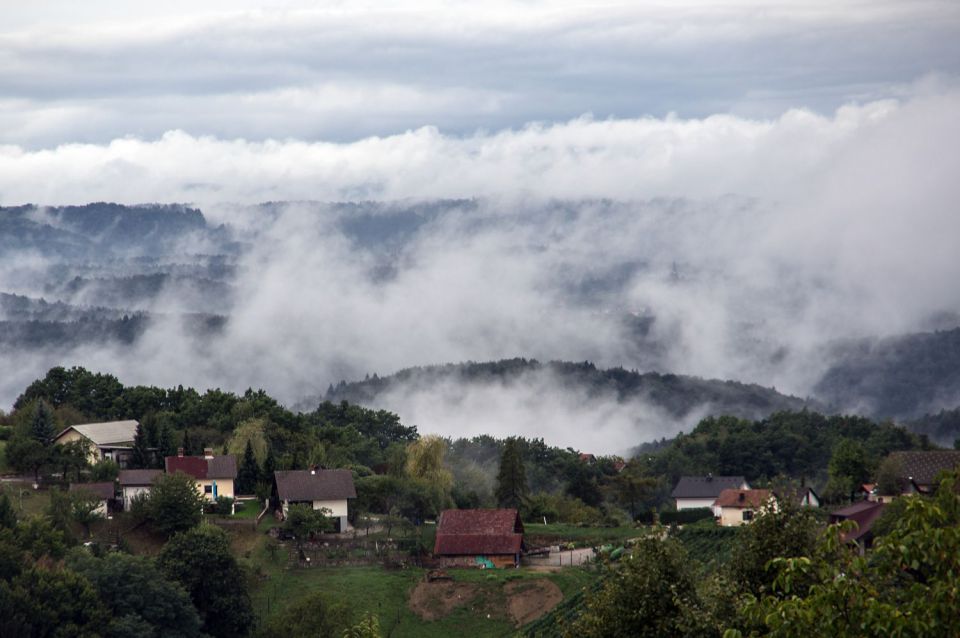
0,0,960,150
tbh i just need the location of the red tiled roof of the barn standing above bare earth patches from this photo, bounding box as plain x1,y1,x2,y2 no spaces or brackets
433,509,523,556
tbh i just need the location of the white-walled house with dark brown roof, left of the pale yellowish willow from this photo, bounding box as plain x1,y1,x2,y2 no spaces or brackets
274,469,357,533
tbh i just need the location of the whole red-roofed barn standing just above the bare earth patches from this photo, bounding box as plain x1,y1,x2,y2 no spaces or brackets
433,509,524,567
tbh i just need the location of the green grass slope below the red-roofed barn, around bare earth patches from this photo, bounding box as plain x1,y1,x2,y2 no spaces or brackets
248,539,595,638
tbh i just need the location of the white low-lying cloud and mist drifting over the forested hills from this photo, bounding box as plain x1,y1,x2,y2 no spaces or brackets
0,86,960,450
